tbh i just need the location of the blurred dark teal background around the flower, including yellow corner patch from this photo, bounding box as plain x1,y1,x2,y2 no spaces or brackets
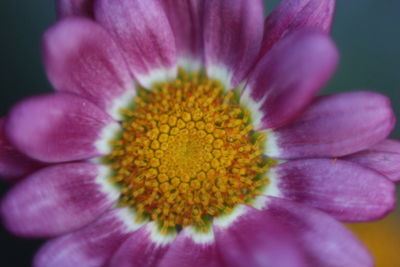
0,0,400,267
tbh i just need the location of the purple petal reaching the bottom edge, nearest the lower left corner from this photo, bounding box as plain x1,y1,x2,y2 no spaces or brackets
34,209,141,267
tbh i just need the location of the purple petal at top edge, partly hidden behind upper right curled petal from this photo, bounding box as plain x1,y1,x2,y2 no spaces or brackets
261,0,336,55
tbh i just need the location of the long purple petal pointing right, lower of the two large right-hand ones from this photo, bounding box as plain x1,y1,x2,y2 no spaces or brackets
271,159,396,222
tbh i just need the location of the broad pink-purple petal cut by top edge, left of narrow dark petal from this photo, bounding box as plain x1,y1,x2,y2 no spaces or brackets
95,0,176,87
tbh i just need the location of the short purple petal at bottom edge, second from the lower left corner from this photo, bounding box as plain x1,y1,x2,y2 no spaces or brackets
108,225,169,267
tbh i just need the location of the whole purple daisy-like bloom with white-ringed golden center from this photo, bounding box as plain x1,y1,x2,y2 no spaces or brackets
0,0,400,267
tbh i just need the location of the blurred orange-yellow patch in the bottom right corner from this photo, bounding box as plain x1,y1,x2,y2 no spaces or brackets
347,210,400,267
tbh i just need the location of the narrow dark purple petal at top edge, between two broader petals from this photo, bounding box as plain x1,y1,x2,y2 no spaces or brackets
161,0,204,68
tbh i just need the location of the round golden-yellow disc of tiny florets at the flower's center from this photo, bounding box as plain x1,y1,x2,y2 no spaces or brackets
105,71,273,232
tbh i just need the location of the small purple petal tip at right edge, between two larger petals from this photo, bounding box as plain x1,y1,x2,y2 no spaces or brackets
343,139,400,182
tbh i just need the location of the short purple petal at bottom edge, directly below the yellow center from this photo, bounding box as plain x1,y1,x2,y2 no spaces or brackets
159,228,220,267
